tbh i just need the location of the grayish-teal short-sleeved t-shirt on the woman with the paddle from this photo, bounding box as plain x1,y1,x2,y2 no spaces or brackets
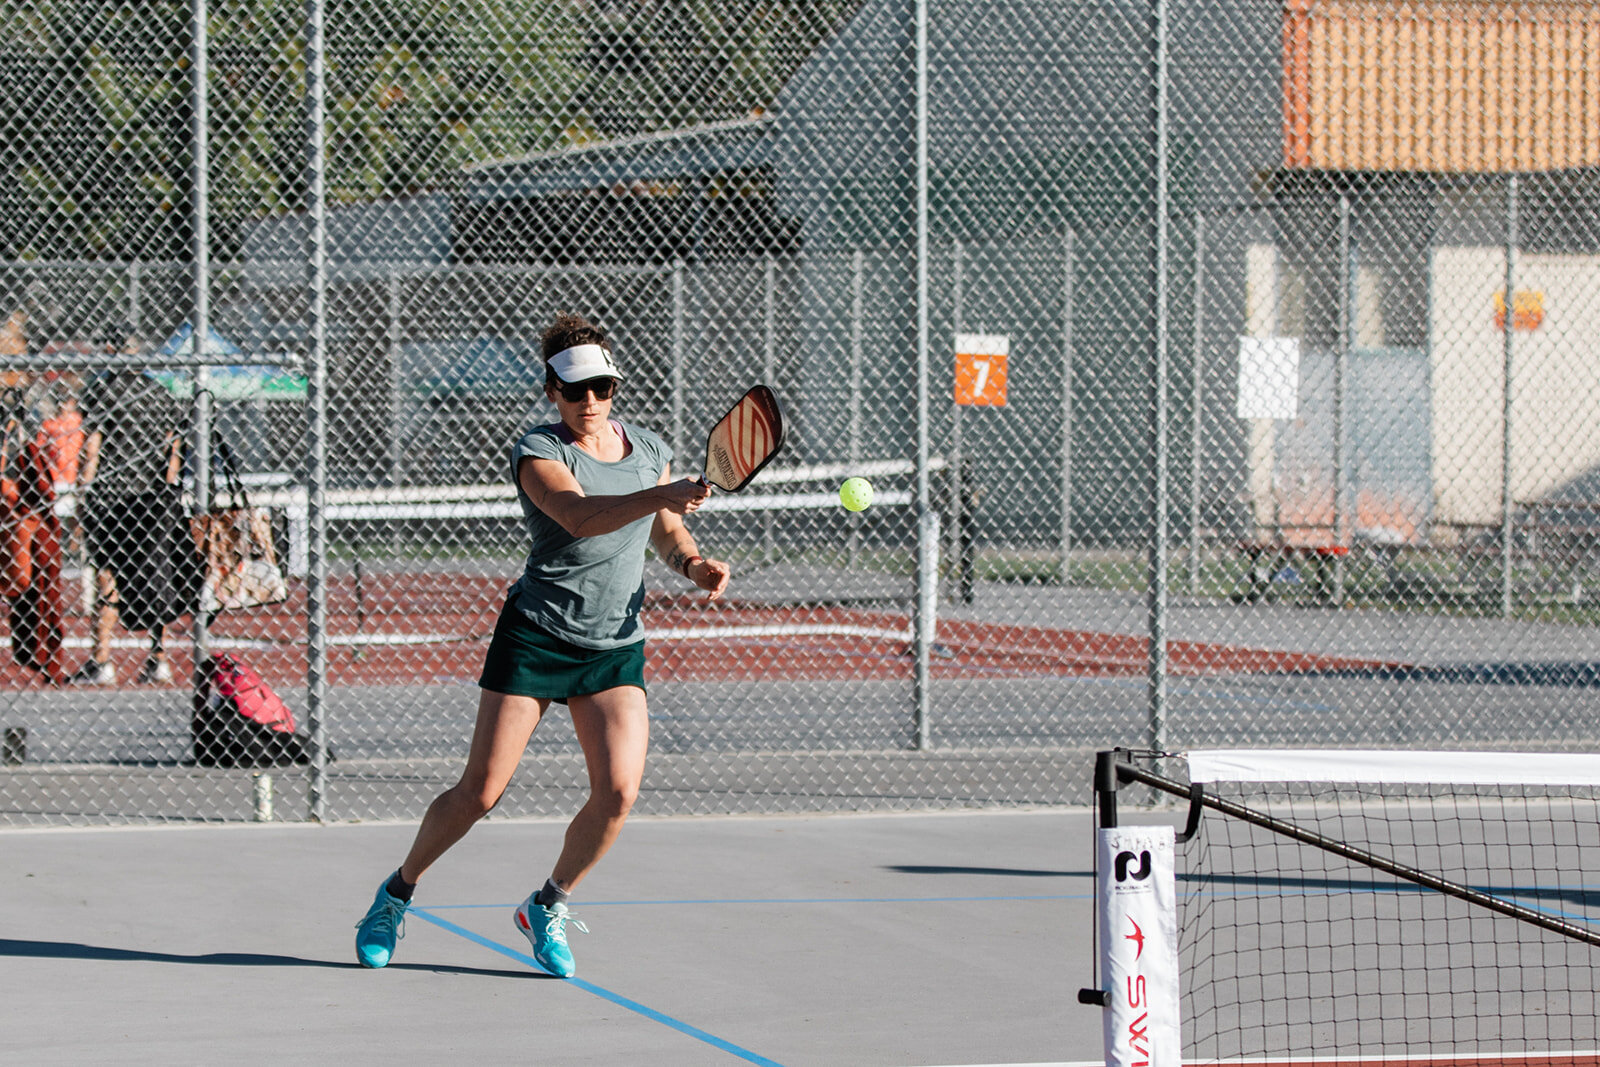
510,419,672,648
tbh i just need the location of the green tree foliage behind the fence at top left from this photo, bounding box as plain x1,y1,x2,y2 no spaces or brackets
0,0,859,261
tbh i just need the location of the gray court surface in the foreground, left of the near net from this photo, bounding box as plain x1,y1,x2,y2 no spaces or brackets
0,808,1101,1067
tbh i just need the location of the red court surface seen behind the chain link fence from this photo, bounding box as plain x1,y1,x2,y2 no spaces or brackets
0,574,1402,689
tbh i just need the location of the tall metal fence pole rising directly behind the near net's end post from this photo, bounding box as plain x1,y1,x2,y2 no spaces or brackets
1146,0,1168,752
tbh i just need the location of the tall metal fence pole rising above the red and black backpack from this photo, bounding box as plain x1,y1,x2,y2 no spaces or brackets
189,0,211,693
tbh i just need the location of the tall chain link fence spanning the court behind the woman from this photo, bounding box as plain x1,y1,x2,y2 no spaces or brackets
0,0,1600,824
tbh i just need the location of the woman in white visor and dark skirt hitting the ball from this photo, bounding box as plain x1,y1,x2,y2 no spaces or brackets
355,308,730,977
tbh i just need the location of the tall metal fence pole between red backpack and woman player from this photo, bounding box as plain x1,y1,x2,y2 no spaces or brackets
306,0,328,822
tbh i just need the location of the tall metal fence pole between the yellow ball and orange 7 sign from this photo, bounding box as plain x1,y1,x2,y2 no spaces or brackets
912,0,939,749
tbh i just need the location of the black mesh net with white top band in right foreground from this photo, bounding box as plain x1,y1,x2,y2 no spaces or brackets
1098,750,1600,1065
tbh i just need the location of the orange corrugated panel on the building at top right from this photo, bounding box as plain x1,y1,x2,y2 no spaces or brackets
1283,0,1600,171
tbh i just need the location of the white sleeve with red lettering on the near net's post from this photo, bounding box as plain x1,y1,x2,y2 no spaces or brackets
1099,825,1182,1067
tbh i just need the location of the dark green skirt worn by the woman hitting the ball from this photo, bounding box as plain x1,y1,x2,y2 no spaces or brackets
478,597,645,704
